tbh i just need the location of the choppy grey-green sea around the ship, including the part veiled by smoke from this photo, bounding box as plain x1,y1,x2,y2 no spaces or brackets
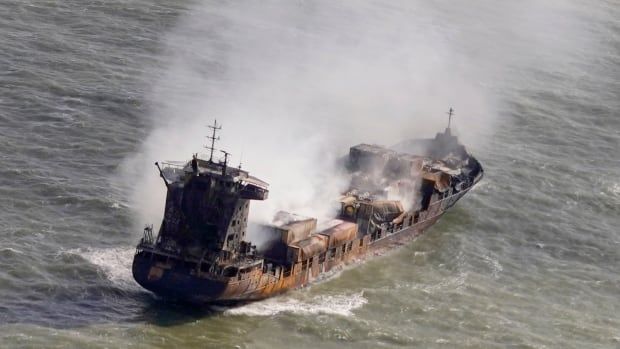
0,0,620,348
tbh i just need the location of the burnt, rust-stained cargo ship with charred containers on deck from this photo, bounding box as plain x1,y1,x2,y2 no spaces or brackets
132,115,484,304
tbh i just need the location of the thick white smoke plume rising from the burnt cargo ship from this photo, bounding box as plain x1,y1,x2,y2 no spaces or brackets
124,0,504,234
